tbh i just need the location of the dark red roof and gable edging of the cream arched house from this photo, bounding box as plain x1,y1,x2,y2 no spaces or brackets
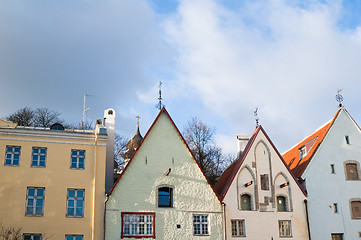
215,125,306,201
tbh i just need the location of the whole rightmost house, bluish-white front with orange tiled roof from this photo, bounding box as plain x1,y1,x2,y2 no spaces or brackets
283,107,361,240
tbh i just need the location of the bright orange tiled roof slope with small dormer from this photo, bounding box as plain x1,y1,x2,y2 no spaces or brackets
282,108,341,178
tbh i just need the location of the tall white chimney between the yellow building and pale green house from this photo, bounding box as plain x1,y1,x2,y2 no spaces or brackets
104,108,116,193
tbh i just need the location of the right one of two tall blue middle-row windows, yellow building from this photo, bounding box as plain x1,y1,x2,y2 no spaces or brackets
66,189,84,217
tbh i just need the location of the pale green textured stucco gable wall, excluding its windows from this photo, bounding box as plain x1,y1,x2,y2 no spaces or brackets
106,113,223,240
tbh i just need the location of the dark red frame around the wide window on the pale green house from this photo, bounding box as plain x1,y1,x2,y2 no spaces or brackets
120,212,155,239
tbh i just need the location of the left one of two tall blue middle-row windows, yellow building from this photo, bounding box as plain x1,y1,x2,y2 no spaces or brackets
25,187,45,216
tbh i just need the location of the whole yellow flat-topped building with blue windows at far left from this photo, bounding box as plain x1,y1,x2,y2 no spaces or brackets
0,111,113,240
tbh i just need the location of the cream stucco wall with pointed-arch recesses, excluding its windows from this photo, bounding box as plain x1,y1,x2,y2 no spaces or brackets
223,131,307,240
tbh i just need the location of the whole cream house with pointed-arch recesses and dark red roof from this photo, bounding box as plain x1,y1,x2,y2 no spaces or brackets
215,126,308,240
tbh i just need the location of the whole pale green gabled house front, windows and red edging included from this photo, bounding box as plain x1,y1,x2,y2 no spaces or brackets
105,108,223,240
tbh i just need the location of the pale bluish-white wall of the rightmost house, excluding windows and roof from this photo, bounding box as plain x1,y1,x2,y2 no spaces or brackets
303,110,361,240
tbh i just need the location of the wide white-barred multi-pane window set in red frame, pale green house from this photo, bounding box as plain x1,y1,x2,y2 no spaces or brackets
122,213,155,238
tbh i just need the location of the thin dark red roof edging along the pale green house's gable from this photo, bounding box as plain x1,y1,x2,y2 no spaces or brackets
109,107,220,201
